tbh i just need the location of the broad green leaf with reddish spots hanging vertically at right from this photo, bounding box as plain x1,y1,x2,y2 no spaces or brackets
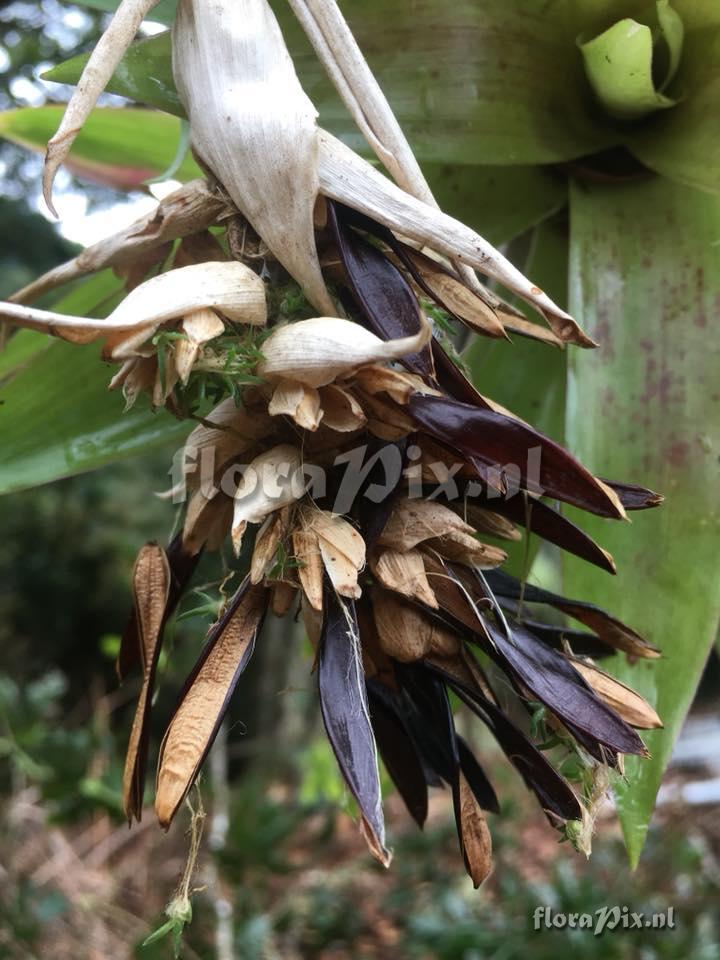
564,179,720,864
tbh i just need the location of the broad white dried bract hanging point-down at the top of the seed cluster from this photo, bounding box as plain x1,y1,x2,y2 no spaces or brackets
173,0,336,315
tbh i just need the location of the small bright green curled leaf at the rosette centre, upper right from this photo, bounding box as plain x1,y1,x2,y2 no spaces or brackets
580,14,682,120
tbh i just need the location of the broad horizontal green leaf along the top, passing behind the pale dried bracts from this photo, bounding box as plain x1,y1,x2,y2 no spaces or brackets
52,0,617,165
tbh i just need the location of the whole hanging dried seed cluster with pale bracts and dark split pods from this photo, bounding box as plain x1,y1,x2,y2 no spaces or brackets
0,0,662,886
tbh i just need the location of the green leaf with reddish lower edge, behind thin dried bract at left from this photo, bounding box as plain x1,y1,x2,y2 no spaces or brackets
0,106,200,190
